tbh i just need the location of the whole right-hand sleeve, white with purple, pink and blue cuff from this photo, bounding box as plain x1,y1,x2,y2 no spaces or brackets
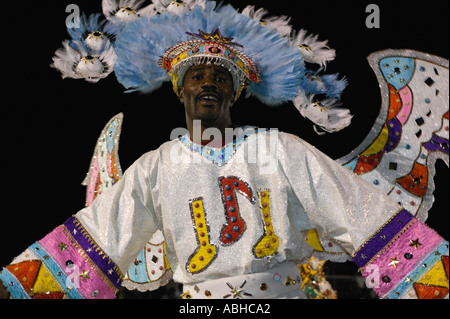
280,132,448,299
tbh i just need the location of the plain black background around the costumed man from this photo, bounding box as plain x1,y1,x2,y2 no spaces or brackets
0,0,449,298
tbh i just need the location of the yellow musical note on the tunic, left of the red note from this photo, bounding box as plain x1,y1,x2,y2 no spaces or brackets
186,197,218,274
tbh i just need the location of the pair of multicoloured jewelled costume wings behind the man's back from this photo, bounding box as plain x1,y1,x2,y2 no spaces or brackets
83,50,449,296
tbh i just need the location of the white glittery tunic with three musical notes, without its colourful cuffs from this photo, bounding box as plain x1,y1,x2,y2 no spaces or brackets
76,128,400,284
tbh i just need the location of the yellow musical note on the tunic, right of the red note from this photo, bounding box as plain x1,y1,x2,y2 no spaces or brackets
253,190,279,258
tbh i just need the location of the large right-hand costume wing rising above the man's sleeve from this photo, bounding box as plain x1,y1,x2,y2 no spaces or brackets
337,50,449,221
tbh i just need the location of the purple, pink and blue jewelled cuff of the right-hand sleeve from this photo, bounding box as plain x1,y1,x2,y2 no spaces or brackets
353,210,449,299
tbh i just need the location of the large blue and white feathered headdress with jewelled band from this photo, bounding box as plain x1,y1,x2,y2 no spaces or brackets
53,0,351,133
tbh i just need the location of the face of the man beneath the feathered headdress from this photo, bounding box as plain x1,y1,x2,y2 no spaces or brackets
179,64,234,127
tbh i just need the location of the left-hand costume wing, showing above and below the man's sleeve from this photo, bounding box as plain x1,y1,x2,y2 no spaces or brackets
82,113,172,291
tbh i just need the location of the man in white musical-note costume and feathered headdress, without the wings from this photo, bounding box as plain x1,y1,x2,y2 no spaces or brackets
0,1,448,298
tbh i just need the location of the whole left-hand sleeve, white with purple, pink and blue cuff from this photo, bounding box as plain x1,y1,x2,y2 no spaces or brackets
0,154,157,299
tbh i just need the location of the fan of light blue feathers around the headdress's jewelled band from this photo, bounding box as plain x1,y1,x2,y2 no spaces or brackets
114,1,346,105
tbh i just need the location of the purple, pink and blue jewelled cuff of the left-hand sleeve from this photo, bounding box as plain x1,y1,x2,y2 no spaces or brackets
0,217,122,299
